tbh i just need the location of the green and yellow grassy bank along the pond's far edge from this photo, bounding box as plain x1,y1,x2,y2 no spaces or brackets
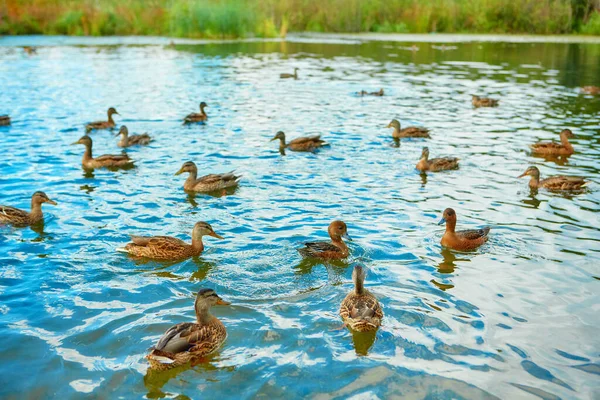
0,0,600,38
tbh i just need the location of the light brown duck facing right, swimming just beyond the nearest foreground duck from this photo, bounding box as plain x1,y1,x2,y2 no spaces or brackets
117,222,223,261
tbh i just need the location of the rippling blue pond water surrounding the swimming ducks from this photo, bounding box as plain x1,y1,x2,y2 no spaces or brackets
0,36,600,399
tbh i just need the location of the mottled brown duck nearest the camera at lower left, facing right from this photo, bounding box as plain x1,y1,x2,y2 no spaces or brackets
146,289,231,371
